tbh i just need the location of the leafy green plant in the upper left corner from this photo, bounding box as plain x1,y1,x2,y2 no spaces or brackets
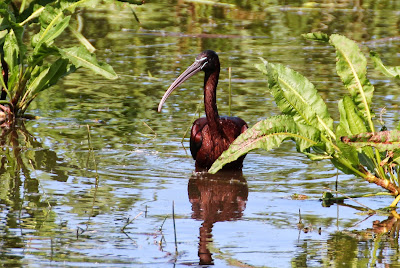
0,0,142,121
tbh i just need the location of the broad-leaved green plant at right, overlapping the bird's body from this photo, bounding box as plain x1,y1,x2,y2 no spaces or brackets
209,33,400,206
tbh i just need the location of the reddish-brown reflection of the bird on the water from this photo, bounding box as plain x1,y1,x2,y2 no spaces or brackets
188,171,249,265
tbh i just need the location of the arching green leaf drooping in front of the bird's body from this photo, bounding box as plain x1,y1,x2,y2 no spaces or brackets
209,115,321,173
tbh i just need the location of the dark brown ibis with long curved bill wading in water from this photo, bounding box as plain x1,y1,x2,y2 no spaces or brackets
158,50,248,171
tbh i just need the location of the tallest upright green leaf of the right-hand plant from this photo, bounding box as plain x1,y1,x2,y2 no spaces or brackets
330,34,374,131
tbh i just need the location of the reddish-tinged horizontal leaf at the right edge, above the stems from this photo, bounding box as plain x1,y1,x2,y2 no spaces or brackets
341,130,400,151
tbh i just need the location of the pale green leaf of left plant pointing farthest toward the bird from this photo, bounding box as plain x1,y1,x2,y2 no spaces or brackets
59,46,118,79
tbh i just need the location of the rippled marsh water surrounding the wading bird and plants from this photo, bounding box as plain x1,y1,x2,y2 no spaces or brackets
0,0,400,267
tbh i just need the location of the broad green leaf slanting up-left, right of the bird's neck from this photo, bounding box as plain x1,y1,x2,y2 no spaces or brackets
256,57,335,139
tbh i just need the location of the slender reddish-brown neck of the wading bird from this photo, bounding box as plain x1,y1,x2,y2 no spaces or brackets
204,70,221,134
